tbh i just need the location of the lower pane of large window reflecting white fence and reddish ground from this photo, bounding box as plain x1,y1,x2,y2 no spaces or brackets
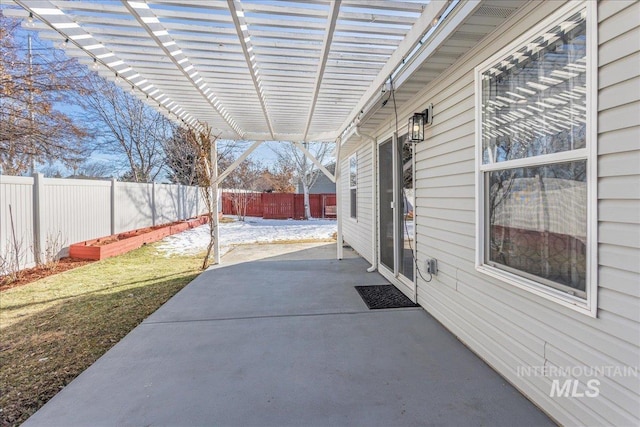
487,161,587,297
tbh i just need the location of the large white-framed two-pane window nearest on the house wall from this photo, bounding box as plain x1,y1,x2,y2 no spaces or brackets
476,6,595,313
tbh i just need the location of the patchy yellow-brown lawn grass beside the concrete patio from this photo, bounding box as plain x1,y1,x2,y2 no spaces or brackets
0,245,202,427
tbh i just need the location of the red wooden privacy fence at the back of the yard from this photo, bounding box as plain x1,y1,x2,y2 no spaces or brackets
222,192,336,219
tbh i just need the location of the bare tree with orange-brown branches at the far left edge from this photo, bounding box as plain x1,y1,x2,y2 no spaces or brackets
0,15,89,175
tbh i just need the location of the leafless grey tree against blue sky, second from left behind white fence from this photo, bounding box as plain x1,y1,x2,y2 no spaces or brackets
78,73,174,182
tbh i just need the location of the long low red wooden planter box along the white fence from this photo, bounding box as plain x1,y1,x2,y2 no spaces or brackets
69,215,209,260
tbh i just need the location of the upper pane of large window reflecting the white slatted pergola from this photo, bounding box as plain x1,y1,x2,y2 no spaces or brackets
482,13,587,164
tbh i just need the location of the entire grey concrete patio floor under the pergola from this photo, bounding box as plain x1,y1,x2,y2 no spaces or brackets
24,245,552,426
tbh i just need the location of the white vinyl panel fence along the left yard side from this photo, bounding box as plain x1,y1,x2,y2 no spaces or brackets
0,174,210,274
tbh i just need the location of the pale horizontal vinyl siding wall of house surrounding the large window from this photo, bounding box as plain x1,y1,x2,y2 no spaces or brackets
341,1,640,425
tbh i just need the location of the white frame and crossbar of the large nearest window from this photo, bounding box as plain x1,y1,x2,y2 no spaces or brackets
474,1,598,317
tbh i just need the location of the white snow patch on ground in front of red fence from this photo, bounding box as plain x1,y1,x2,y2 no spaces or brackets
158,217,337,255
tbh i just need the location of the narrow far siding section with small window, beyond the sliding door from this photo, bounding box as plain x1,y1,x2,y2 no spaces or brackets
340,142,375,263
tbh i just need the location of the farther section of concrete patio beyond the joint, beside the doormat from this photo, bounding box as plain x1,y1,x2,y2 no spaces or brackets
147,244,387,322
